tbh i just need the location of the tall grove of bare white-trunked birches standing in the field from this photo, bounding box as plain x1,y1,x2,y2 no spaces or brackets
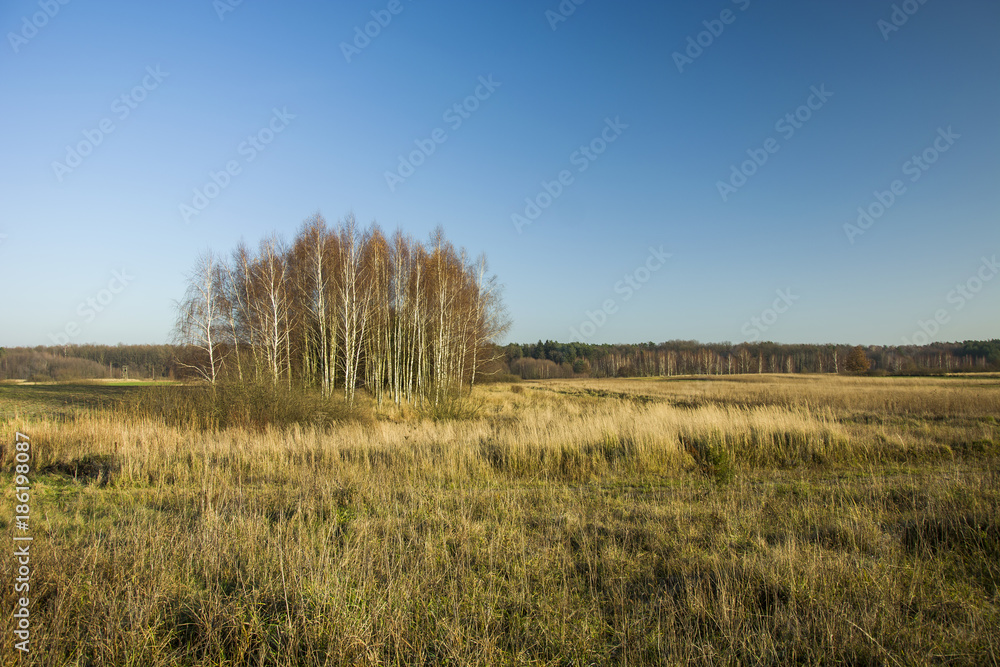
177,215,508,403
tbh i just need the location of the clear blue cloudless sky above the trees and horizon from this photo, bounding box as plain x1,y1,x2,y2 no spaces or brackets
0,0,1000,346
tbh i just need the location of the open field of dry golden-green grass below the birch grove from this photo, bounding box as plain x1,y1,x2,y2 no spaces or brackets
0,375,1000,666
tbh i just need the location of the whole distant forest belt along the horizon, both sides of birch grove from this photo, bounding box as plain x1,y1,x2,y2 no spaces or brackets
0,339,1000,382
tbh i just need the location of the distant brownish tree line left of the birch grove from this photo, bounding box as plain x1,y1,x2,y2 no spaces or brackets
0,345,179,381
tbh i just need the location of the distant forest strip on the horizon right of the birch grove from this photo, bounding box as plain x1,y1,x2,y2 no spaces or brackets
504,340,1000,379
